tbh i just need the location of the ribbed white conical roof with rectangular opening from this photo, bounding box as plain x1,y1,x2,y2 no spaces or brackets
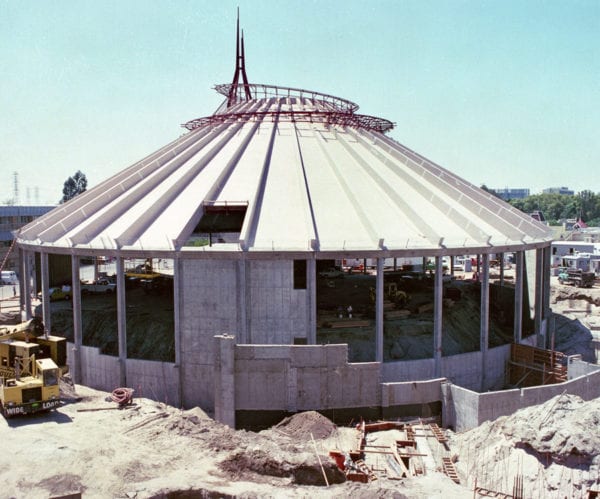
19,85,551,256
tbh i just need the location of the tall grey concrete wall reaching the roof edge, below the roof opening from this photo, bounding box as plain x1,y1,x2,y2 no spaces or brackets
179,259,308,411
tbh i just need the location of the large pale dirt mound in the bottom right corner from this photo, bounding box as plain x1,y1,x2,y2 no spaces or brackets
452,395,600,497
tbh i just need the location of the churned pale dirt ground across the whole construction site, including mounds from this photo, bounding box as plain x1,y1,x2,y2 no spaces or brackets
0,278,600,498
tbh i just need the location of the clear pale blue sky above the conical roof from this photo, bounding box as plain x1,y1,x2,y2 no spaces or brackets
0,0,600,204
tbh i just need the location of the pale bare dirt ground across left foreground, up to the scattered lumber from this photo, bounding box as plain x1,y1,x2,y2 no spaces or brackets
0,385,467,498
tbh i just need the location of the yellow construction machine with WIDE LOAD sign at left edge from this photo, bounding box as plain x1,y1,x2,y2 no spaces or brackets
0,318,68,418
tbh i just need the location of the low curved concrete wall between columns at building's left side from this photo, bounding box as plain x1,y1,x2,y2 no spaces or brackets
67,343,180,407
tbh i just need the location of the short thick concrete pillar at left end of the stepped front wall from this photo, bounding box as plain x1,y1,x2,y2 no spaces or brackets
215,334,235,428
